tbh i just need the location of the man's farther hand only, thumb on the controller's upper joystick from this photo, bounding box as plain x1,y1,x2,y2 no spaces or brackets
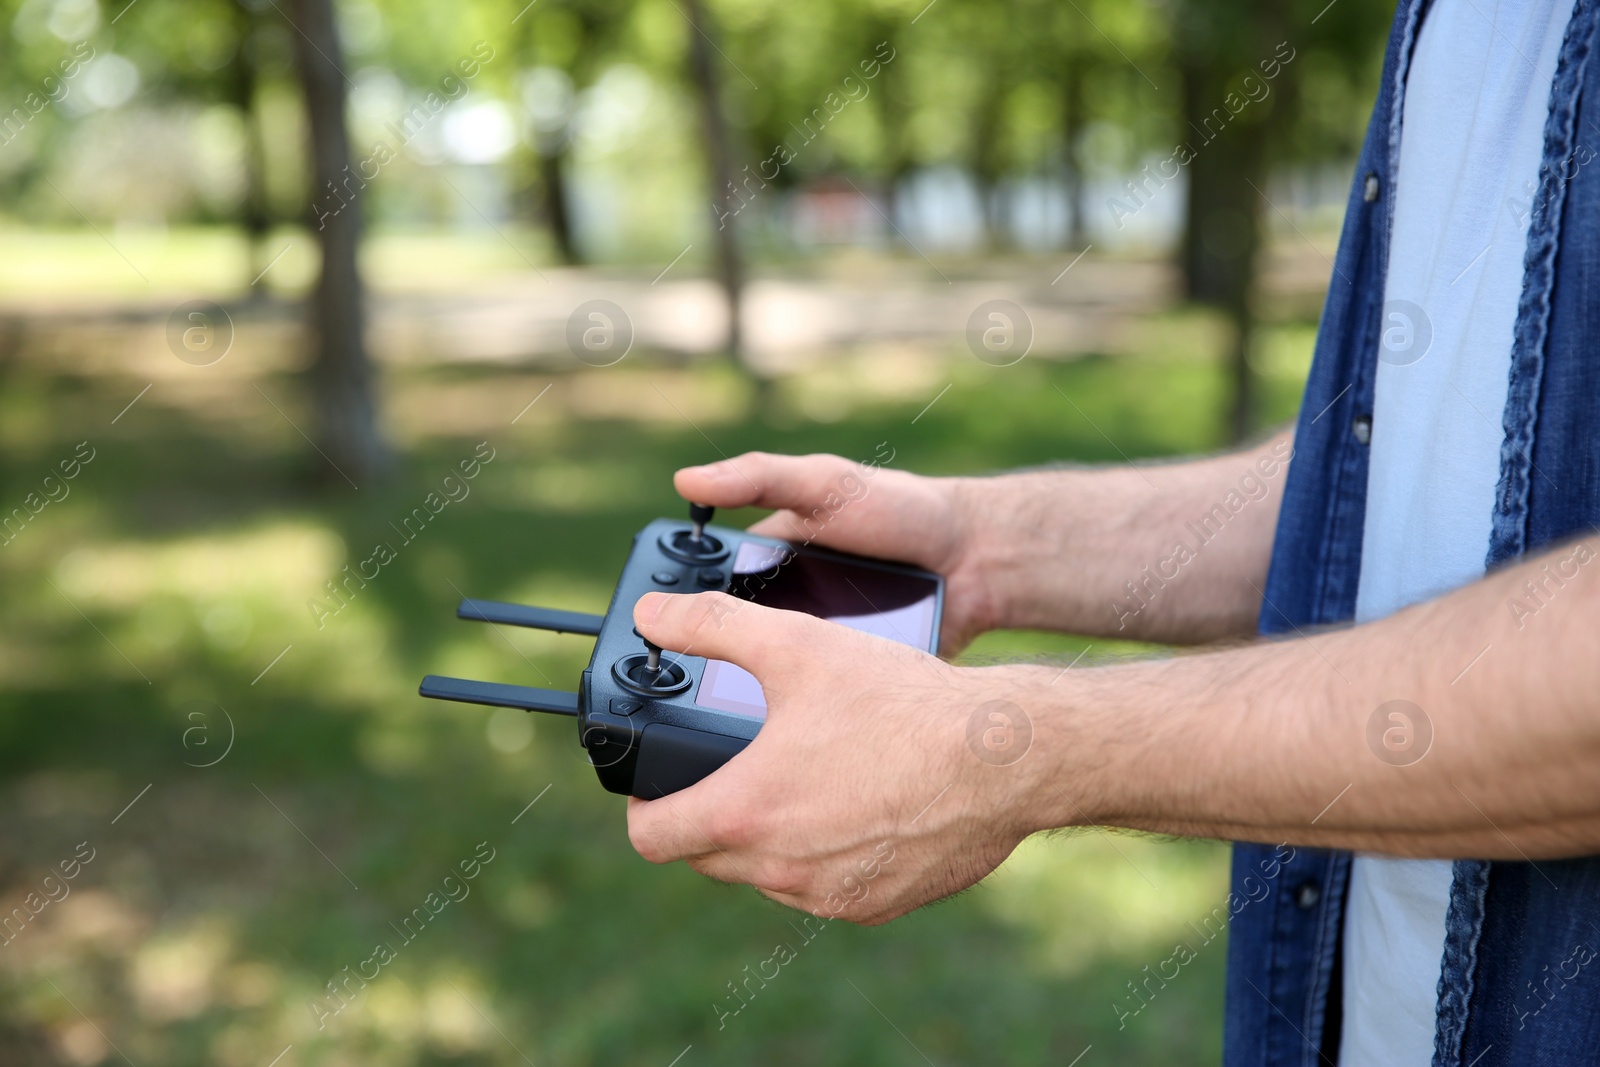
674,453,995,656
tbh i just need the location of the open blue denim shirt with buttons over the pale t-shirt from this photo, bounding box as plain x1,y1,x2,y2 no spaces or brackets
1224,0,1600,1067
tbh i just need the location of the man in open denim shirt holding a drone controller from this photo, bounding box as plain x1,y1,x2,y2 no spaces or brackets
629,0,1600,1067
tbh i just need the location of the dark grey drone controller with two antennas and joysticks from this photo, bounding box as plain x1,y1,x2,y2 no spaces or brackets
418,504,944,800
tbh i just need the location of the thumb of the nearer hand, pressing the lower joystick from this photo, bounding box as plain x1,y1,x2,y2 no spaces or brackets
634,592,826,678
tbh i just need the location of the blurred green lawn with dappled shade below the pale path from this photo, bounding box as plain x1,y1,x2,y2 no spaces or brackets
0,326,1309,1067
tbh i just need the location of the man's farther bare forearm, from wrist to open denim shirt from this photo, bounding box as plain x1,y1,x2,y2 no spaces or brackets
957,434,1291,643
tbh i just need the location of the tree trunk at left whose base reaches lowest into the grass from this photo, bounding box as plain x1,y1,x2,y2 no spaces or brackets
291,0,390,486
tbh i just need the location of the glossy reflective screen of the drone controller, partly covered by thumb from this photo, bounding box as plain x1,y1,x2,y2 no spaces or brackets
694,541,938,718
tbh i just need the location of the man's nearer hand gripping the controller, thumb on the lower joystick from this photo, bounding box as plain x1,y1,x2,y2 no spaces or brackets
627,591,1029,925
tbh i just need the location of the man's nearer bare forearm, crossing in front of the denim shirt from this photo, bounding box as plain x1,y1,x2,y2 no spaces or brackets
1000,542,1600,859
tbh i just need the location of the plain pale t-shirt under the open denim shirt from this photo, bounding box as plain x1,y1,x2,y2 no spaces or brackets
1339,0,1573,1067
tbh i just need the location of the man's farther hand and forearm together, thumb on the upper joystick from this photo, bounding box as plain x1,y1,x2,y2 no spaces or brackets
675,435,1293,656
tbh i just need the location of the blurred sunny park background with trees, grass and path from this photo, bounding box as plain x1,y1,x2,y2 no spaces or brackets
0,0,1390,1067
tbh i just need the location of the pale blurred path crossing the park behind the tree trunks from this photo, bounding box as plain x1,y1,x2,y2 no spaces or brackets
0,243,1330,374
